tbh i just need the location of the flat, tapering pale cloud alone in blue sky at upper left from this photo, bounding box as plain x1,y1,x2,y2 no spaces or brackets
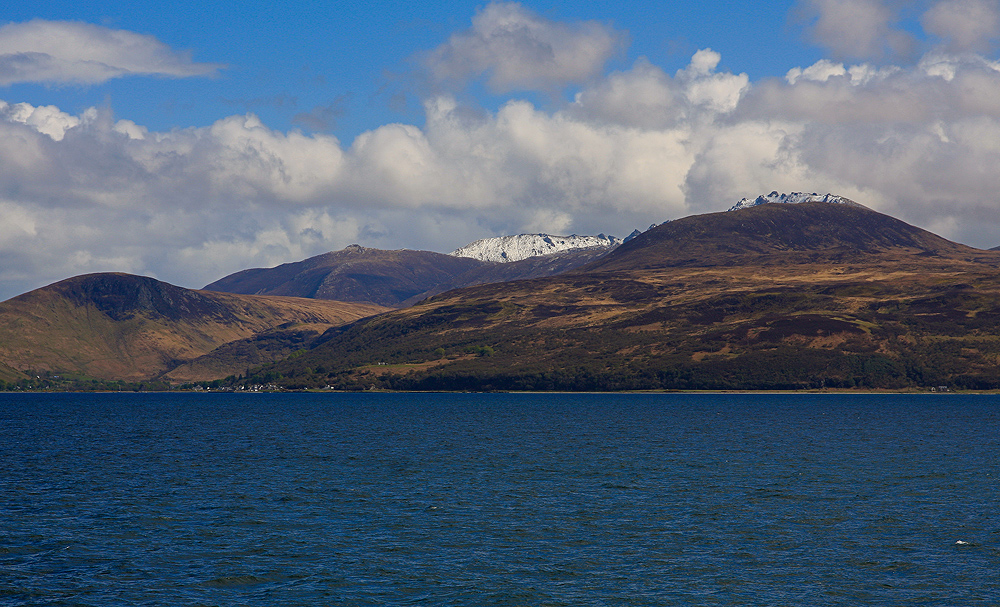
0,19,222,85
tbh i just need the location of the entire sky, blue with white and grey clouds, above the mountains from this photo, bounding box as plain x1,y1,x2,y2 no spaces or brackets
0,0,1000,299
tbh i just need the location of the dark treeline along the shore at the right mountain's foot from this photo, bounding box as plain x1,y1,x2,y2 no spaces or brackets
237,348,1000,392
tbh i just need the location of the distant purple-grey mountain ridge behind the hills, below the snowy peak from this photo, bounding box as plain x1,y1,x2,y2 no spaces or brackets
205,245,607,307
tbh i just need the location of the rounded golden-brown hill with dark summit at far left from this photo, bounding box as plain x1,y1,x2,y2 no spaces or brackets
0,274,385,381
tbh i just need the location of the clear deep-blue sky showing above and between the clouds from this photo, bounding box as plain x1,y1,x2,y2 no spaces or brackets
0,0,822,141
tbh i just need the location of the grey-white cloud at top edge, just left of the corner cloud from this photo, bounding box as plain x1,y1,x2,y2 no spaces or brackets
799,0,916,59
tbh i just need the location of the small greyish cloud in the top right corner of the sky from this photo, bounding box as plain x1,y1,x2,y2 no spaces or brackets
921,0,1000,52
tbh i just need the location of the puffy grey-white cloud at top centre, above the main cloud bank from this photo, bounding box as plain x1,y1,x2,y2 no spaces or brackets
422,2,623,92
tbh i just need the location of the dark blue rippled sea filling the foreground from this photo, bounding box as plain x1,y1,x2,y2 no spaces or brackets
0,393,1000,607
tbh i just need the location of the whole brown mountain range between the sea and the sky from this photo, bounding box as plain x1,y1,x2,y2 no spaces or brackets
0,193,1000,390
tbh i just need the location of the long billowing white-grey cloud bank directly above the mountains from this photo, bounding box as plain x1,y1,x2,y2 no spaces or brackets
0,3,1000,297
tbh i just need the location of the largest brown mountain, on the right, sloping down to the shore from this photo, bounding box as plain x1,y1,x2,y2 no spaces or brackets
240,202,1000,390
